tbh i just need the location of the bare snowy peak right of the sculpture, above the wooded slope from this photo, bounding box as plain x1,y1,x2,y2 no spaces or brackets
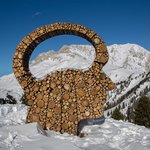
104,44,150,82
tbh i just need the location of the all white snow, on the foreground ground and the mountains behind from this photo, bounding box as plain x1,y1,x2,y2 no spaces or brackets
0,44,150,150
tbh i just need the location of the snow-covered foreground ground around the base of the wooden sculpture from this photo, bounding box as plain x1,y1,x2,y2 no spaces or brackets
0,104,150,150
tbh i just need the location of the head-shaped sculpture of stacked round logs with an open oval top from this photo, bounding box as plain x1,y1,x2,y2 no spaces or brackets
13,23,115,135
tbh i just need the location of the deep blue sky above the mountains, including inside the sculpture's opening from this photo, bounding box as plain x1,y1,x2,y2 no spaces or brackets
0,0,150,76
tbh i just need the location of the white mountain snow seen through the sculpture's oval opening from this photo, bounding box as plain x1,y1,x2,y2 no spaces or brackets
30,45,95,79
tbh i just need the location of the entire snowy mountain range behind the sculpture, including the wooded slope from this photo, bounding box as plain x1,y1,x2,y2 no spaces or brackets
0,44,150,117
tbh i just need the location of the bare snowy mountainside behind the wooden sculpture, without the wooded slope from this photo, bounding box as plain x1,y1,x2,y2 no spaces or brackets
0,44,150,100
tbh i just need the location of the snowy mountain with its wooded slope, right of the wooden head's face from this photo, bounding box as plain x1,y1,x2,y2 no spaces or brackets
105,44,150,119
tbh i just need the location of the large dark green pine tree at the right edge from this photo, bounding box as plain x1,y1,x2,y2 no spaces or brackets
134,96,150,128
